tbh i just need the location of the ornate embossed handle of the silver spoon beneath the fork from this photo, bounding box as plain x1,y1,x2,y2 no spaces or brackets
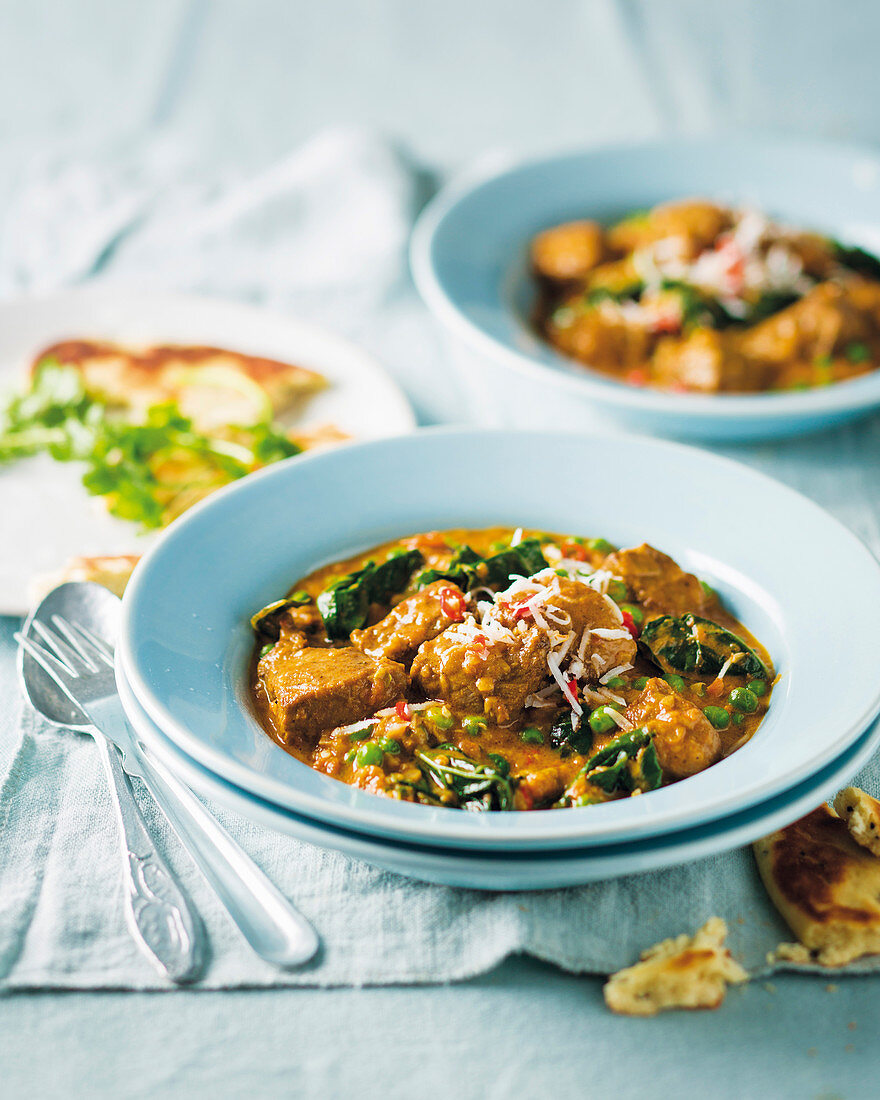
94,730,204,982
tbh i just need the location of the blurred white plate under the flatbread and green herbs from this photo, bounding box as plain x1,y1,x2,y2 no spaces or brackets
0,287,416,614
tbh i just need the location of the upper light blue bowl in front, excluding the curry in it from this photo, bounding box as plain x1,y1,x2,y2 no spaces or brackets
118,429,880,850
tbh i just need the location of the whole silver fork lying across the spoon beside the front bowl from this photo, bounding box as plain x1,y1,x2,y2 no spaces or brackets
15,615,318,967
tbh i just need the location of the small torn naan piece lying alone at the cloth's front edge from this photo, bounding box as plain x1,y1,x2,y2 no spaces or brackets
604,916,748,1016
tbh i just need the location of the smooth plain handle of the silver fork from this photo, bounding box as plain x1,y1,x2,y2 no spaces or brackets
138,741,319,967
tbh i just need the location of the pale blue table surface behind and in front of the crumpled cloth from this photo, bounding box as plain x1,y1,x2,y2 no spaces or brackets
0,0,880,1098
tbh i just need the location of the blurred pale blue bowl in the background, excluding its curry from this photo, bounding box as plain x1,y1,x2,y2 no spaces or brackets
411,138,880,441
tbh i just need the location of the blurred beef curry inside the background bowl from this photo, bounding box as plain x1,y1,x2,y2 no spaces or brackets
531,199,880,394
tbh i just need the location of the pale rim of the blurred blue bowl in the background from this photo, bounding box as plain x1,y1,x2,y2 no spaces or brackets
409,133,880,422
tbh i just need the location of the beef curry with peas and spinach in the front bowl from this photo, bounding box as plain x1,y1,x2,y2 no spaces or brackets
245,528,774,810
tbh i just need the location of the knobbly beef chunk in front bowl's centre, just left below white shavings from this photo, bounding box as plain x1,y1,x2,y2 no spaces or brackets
411,623,550,724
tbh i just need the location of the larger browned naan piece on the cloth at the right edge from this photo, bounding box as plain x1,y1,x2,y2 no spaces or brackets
752,803,880,966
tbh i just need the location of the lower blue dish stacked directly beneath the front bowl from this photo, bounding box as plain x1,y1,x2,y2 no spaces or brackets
117,672,880,890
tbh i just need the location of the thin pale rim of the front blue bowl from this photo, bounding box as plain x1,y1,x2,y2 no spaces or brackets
117,427,880,846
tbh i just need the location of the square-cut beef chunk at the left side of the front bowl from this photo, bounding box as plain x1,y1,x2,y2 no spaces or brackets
257,638,407,748
